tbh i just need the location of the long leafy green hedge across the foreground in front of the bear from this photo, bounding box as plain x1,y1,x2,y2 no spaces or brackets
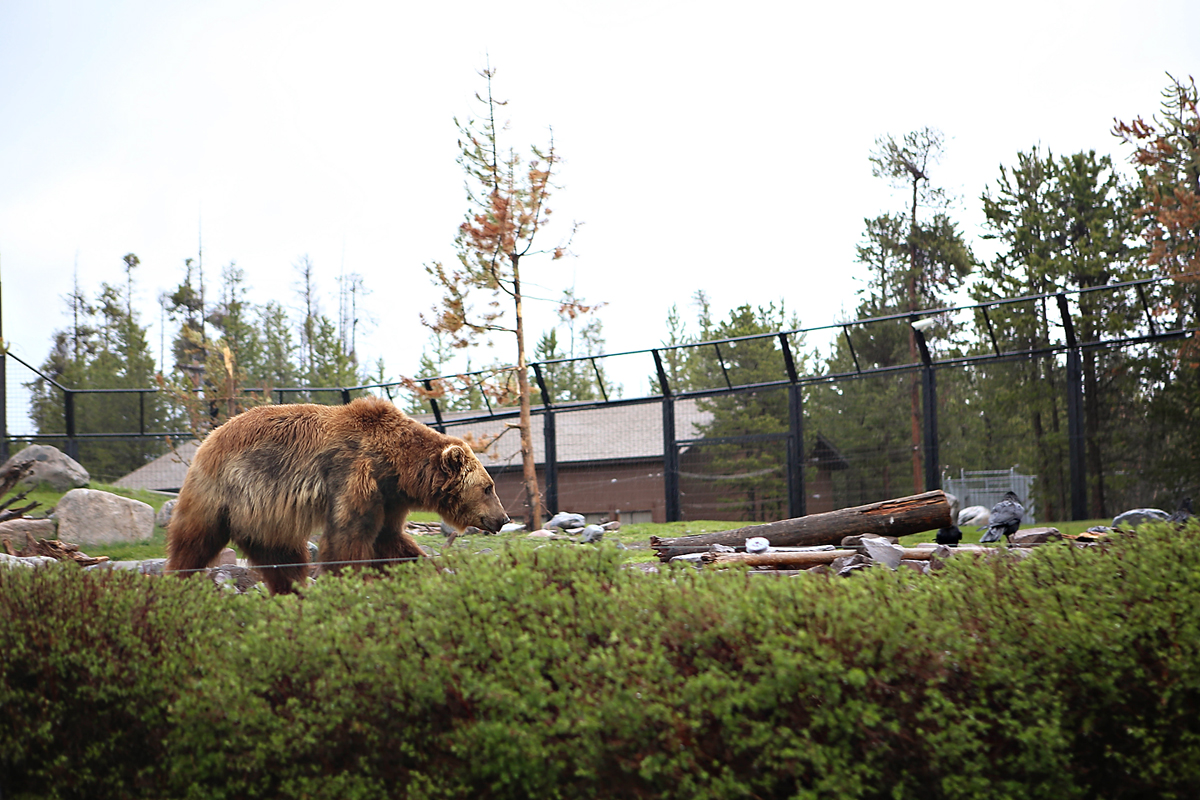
0,525,1200,799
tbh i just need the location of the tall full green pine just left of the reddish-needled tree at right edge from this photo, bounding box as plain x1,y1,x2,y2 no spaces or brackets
973,149,1144,517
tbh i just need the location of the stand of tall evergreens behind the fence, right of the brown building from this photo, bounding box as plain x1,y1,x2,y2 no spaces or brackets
662,78,1200,519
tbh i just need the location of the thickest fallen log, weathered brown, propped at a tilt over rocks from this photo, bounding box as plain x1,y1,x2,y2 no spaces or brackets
650,489,952,561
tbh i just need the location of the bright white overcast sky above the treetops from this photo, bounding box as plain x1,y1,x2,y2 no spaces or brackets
0,0,1200,393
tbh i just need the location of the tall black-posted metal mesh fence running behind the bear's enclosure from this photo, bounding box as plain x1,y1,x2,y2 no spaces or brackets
0,279,1200,522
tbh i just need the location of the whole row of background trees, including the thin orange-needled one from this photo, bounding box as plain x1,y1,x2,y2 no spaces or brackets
21,73,1200,518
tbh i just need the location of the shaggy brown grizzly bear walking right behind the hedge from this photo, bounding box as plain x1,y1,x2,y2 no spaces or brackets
166,397,509,594
